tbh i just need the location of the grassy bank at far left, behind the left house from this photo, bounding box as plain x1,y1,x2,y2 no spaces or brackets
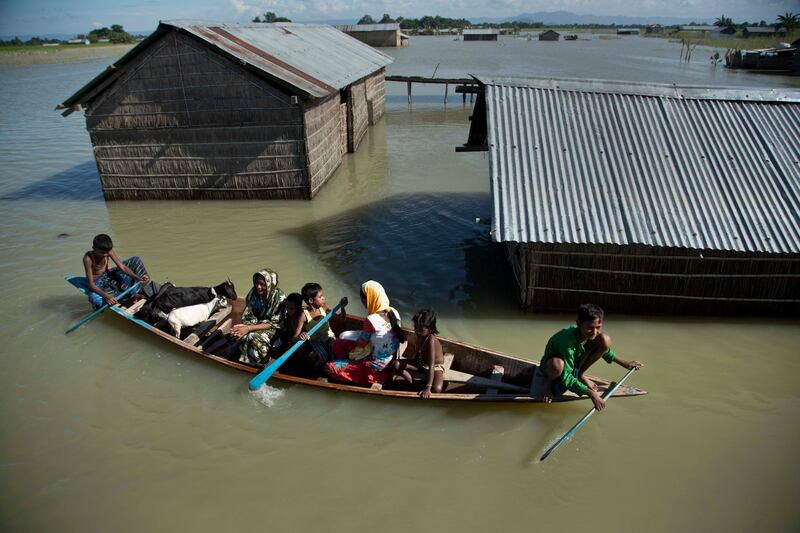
0,43,134,67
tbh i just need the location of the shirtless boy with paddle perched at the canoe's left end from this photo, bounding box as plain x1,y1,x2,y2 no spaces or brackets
83,233,150,309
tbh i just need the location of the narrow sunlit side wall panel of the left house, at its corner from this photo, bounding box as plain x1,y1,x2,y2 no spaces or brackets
305,93,342,198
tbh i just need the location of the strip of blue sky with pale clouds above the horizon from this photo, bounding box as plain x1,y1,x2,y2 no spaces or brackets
0,0,800,35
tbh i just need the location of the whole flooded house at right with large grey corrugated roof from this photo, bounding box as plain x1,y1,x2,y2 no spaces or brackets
457,77,800,316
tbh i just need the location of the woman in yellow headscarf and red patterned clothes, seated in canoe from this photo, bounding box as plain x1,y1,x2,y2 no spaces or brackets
326,280,406,385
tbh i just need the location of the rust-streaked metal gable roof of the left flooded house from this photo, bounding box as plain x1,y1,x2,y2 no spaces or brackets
59,20,394,108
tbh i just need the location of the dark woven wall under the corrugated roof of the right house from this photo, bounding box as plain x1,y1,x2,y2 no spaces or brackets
506,243,800,316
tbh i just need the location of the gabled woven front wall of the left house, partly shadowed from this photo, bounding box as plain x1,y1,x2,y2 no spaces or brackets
86,32,311,200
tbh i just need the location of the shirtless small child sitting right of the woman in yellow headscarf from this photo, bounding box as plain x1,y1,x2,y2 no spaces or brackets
394,309,444,400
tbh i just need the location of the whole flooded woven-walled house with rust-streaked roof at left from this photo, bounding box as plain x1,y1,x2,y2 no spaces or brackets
58,20,392,200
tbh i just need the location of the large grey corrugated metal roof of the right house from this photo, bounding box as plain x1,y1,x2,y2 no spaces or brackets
479,77,800,253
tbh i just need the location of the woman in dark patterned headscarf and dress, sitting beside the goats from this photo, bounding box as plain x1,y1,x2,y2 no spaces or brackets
231,268,286,365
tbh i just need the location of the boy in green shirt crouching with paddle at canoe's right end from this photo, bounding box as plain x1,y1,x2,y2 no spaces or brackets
531,304,642,411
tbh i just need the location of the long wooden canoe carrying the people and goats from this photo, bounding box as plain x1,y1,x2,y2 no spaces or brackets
67,280,647,402
